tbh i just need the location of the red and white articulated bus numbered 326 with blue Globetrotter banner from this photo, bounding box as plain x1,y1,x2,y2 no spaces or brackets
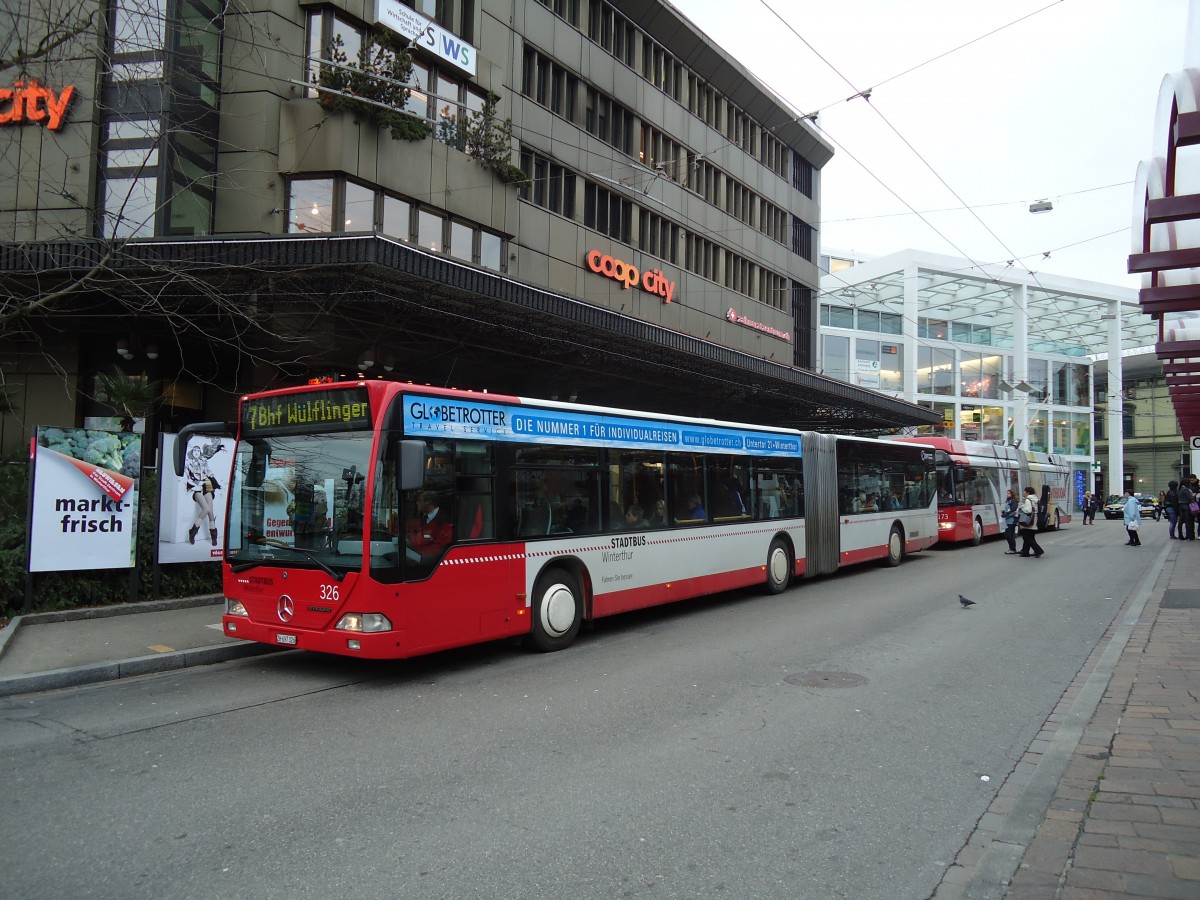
175,382,937,659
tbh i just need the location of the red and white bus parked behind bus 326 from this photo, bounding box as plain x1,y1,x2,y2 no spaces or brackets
896,437,1072,544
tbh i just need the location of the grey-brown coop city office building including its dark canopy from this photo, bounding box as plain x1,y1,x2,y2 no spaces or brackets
0,0,929,450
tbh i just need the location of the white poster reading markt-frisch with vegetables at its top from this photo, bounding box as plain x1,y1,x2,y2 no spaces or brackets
29,426,142,572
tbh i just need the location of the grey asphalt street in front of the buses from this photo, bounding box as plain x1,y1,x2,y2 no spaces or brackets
0,522,1165,898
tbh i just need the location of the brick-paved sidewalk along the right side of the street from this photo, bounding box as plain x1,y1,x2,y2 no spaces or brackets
934,541,1200,900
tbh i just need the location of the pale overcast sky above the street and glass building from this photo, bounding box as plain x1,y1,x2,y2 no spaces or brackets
672,0,1188,287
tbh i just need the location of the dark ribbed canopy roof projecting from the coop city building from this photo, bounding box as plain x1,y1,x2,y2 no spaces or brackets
0,234,937,432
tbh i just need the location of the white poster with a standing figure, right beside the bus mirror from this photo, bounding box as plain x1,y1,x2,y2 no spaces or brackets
158,434,233,564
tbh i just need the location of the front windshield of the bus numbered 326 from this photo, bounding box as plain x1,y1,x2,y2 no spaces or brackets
227,431,372,577
